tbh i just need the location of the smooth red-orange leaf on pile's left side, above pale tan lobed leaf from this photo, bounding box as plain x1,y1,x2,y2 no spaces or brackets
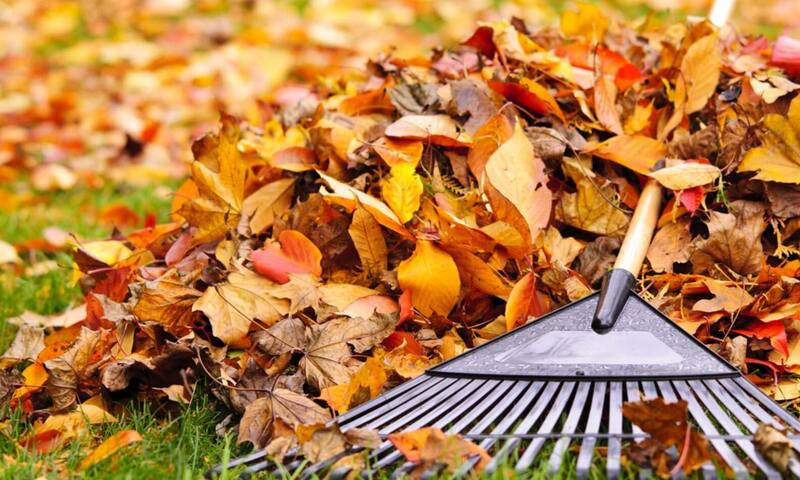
250,230,322,283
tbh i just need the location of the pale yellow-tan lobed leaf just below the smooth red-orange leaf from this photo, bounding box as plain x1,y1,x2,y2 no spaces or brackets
192,271,289,345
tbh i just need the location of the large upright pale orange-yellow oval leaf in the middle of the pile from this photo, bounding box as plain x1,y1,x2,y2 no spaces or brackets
484,122,553,238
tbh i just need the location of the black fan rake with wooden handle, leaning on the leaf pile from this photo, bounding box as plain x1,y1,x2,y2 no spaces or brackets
207,0,800,479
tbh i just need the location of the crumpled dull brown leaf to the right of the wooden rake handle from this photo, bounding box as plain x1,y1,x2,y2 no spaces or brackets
690,200,766,275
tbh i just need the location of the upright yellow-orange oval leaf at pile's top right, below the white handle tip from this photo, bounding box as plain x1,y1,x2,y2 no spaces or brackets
681,33,722,114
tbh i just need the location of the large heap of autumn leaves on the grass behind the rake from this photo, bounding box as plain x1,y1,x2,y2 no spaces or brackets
7,1,800,476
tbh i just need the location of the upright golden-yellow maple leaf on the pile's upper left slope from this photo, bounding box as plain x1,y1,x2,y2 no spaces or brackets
176,114,246,243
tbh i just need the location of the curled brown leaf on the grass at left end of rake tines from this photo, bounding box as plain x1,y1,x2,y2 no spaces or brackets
237,388,330,448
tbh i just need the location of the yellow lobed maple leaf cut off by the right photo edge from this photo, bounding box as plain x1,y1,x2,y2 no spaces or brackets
739,97,800,183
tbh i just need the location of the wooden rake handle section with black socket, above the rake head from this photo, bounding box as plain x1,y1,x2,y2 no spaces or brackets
592,179,662,333
